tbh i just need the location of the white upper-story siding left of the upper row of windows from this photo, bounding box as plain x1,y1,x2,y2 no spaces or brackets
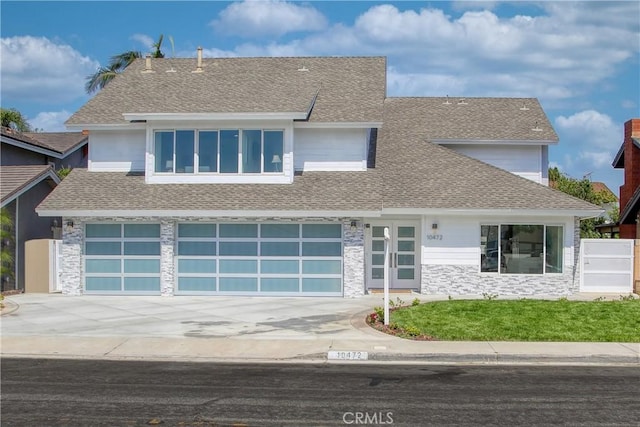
88,129,145,172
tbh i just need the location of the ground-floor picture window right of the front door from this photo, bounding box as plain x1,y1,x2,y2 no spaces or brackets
480,224,564,274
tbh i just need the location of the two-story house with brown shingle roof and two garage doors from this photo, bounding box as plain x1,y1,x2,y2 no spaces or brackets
38,54,600,297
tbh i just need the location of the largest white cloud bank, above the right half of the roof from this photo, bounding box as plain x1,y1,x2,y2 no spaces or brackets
210,2,640,102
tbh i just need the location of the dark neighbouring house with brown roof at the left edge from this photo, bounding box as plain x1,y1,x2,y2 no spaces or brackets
0,127,88,291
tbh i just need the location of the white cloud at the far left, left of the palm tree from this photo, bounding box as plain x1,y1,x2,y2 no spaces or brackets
0,36,99,104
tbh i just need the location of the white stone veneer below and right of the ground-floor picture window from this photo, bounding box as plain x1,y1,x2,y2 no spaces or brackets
421,218,580,297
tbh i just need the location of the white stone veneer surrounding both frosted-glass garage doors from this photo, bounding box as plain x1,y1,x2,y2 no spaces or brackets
62,217,365,297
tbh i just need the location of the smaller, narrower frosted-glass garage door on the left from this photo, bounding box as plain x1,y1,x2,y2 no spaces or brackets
84,223,160,295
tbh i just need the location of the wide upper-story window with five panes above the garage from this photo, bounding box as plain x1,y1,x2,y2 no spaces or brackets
154,129,284,174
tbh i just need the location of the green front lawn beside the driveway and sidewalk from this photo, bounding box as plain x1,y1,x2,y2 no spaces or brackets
390,299,640,342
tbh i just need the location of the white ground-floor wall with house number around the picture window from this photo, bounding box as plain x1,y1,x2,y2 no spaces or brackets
421,216,574,269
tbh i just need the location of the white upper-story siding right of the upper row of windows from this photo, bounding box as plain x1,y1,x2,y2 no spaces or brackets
294,129,368,171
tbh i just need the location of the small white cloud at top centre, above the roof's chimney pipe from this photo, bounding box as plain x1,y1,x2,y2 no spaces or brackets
211,0,327,37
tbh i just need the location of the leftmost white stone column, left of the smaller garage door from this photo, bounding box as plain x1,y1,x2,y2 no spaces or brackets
61,217,84,295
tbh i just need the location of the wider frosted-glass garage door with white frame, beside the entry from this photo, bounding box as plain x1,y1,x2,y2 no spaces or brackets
176,223,342,296
